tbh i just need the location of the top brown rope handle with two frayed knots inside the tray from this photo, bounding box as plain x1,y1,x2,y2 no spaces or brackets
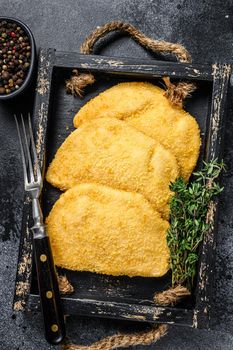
66,22,196,107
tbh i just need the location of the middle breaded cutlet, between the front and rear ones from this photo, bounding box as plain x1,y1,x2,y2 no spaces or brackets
46,118,179,217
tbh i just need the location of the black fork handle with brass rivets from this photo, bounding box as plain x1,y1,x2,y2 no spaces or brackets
32,225,66,344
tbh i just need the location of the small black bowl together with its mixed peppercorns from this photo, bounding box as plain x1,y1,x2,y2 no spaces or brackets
0,17,36,100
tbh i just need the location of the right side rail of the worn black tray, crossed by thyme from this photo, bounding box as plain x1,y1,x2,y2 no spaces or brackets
193,64,231,328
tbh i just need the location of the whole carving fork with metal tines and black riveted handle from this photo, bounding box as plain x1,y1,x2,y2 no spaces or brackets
14,114,65,344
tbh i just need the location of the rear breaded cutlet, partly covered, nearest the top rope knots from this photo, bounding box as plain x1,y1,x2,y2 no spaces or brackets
74,82,201,180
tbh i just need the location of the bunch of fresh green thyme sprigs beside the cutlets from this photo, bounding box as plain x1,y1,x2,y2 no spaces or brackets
167,160,224,288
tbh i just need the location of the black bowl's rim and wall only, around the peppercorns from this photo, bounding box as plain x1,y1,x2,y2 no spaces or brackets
0,16,36,101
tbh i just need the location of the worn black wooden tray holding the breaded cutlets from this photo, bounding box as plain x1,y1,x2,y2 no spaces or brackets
14,49,231,328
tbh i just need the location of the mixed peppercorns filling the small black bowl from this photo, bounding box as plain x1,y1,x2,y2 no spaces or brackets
0,20,31,95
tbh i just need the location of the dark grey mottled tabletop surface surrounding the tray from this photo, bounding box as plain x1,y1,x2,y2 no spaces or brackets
0,0,233,350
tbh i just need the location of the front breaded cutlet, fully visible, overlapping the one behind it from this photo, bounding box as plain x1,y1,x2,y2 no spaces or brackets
47,183,170,277
